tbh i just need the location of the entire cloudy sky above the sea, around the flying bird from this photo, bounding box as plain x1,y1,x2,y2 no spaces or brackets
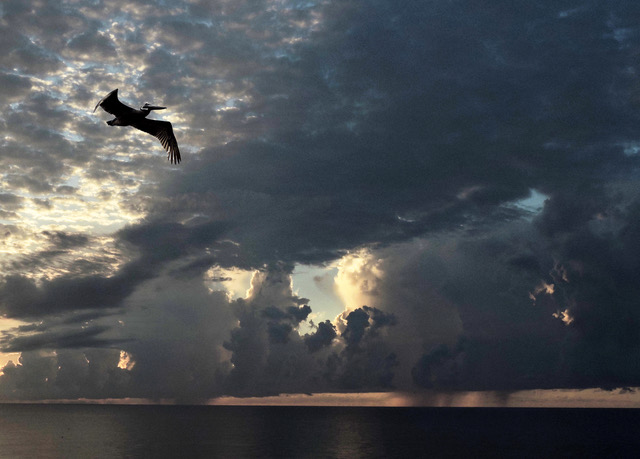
0,0,640,404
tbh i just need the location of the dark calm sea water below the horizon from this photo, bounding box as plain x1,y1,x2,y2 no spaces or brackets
0,405,640,459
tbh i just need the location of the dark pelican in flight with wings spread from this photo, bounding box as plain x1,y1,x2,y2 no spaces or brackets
93,89,180,164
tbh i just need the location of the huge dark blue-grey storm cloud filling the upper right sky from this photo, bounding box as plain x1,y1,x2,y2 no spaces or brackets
154,2,638,261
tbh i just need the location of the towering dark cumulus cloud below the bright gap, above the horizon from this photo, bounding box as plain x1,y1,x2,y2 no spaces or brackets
223,266,397,396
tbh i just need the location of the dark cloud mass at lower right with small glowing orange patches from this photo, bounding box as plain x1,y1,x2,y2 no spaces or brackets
402,192,640,390
